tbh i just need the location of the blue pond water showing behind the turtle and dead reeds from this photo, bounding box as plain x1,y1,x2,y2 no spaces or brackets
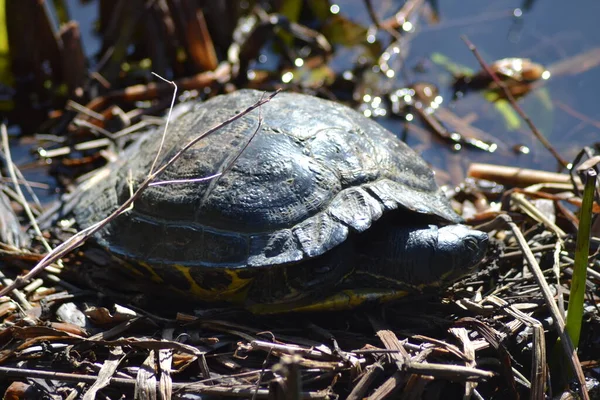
3,0,600,194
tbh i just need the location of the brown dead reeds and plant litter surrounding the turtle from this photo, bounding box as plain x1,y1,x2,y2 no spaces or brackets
0,0,600,399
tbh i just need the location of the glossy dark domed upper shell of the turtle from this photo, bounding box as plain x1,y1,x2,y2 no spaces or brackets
74,90,460,269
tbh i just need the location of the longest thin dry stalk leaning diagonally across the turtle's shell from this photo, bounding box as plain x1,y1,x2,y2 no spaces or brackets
0,90,279,296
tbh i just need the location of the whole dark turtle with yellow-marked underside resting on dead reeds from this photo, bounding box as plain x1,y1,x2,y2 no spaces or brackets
73,89,488,313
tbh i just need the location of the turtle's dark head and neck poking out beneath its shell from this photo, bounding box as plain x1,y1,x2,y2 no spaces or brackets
350,224,488,292
